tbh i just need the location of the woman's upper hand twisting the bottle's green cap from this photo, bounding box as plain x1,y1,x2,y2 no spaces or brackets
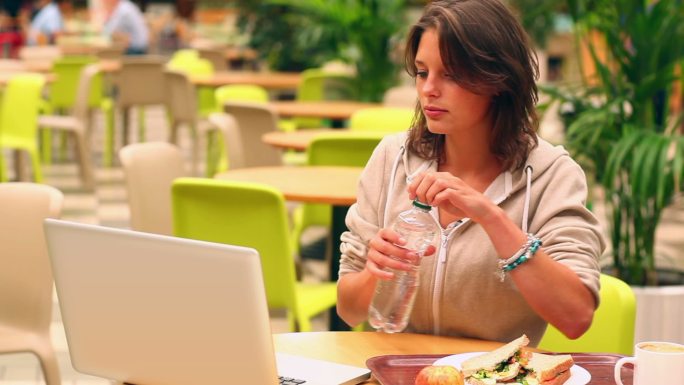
408,171,493,222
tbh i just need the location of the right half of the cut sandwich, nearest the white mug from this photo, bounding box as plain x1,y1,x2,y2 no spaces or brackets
516,353,574,385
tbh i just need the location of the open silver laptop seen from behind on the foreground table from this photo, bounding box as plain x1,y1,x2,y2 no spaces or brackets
45,219,370,385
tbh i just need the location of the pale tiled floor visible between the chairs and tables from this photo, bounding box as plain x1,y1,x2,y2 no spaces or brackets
0,108,327,385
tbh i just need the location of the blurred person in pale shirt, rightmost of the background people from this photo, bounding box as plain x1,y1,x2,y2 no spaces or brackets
102,0,149,55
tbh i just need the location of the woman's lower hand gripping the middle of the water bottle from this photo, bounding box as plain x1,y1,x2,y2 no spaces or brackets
366,228,435,279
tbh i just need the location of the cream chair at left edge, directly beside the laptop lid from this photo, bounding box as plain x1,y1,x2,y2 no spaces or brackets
0,183,64,385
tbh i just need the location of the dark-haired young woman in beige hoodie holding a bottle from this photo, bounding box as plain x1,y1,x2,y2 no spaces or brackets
337,0,604,345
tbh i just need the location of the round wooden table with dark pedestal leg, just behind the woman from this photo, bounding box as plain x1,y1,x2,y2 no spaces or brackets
215,166,363,330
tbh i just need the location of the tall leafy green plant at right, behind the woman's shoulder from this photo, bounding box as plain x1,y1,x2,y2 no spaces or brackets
547,0,684,285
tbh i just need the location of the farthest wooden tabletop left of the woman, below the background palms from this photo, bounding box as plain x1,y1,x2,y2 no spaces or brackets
191,71,301,90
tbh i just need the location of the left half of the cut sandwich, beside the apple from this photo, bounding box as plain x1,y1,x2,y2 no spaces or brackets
461,334,532,385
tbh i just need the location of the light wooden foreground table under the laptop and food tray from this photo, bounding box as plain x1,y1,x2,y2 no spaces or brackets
273,332,633,385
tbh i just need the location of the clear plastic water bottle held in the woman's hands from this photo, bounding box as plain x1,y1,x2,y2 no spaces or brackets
368,200,438,333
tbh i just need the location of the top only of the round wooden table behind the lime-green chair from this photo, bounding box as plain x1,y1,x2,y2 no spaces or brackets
215,166,363,206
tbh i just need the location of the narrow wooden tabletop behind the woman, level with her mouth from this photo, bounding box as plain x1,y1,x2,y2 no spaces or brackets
269,100,382,120
